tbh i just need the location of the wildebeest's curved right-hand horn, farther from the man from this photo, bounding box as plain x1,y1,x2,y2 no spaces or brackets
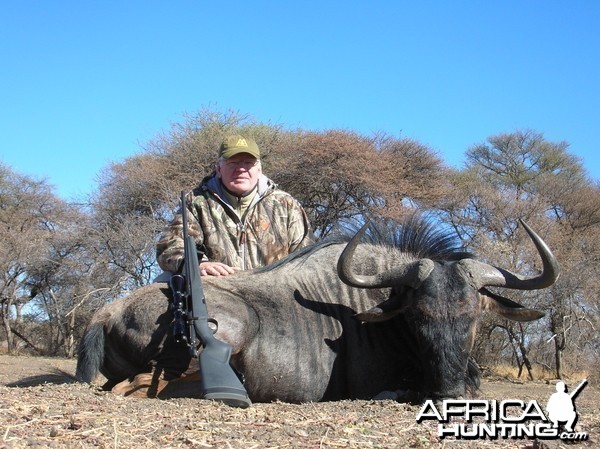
462,220,560,290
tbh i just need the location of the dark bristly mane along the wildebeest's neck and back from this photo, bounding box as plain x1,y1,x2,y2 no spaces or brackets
254,214,474,273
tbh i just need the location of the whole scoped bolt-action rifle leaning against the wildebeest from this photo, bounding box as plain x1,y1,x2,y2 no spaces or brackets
170,192,252,407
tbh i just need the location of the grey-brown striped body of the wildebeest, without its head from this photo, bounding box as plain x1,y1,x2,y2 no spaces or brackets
85,245,408,402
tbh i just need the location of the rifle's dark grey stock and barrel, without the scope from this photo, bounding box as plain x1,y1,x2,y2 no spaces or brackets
176,192,252,407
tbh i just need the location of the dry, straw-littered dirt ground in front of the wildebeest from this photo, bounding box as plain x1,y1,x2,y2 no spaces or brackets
0,355,600,449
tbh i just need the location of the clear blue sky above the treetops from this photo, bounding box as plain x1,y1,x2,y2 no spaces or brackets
0,0,600,200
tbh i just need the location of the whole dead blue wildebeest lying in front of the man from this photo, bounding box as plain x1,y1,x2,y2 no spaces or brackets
77,219,558,402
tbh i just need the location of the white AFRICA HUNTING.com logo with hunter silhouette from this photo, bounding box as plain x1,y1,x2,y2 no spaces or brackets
417,380,588,441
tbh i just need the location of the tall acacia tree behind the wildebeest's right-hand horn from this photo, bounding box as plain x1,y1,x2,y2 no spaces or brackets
441,131,598,377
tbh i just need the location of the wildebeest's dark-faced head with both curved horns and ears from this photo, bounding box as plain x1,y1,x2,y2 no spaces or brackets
338,221,559,398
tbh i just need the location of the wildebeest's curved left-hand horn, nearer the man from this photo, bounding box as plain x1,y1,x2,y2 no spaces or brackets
337,223,433,288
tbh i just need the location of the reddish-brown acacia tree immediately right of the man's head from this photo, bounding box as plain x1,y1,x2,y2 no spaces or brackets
268,131,387,237
